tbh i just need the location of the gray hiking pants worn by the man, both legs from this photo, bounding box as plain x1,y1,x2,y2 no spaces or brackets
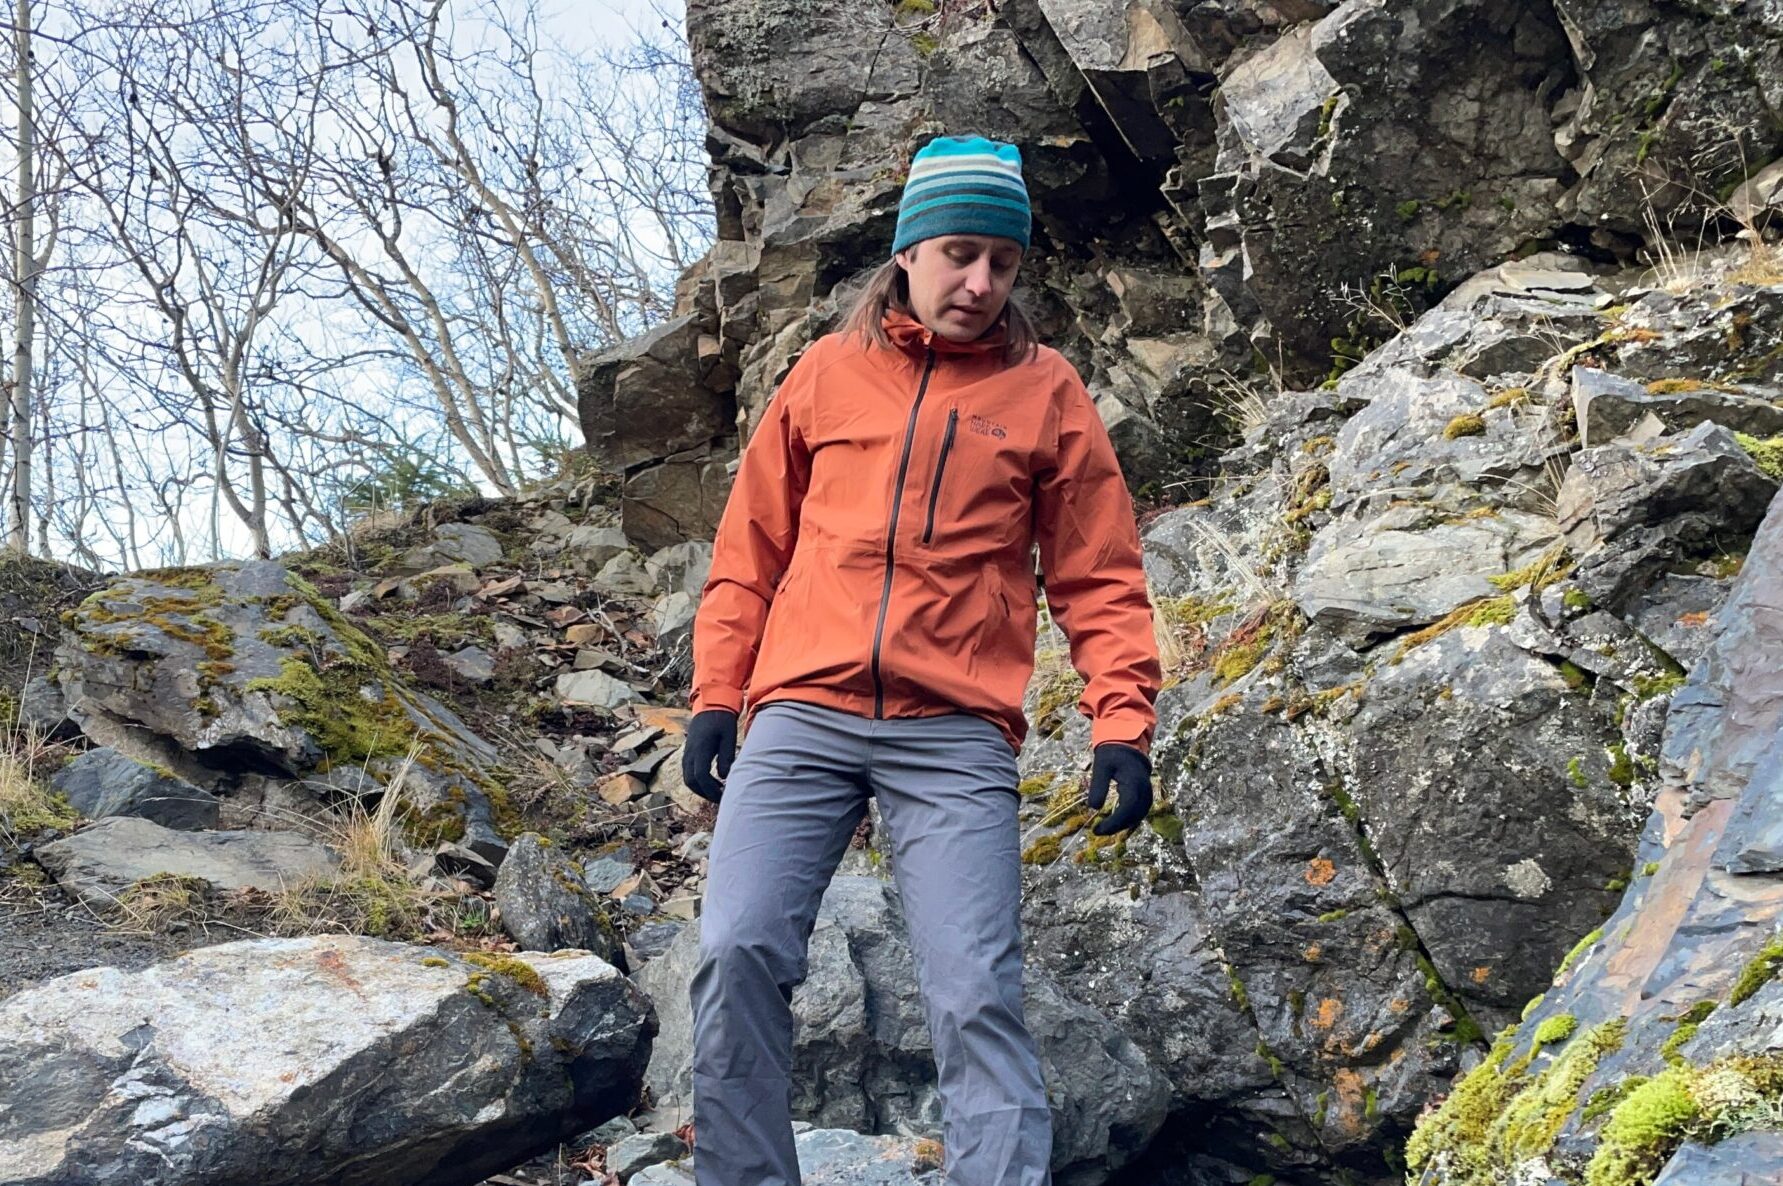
692,703,1052,1186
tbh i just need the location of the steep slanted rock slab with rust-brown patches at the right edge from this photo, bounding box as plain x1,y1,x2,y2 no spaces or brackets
1410,481,1783,1186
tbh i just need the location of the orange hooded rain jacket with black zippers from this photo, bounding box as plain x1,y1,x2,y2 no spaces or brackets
692,312,1159,751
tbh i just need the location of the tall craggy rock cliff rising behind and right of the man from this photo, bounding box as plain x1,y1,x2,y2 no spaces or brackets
581,0,1783,1186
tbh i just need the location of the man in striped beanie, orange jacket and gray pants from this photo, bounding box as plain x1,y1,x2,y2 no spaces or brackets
683,137,1159,1186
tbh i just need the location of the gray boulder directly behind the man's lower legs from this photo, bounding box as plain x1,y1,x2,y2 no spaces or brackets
637,876,1168,1182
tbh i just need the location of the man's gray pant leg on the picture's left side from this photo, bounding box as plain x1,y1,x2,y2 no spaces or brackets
690,704,867,1186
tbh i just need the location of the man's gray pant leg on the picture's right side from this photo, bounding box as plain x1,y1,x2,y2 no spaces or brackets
870,715,1052,1186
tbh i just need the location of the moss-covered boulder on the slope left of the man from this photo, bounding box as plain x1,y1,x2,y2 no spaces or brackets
55,560,506,861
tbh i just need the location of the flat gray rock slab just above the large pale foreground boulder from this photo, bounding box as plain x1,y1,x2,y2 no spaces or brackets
37,815,339,906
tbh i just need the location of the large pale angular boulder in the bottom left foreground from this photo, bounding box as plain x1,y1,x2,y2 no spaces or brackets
0,936,653,1186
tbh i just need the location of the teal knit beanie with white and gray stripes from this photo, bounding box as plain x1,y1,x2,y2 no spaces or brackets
892,136,1031,255
